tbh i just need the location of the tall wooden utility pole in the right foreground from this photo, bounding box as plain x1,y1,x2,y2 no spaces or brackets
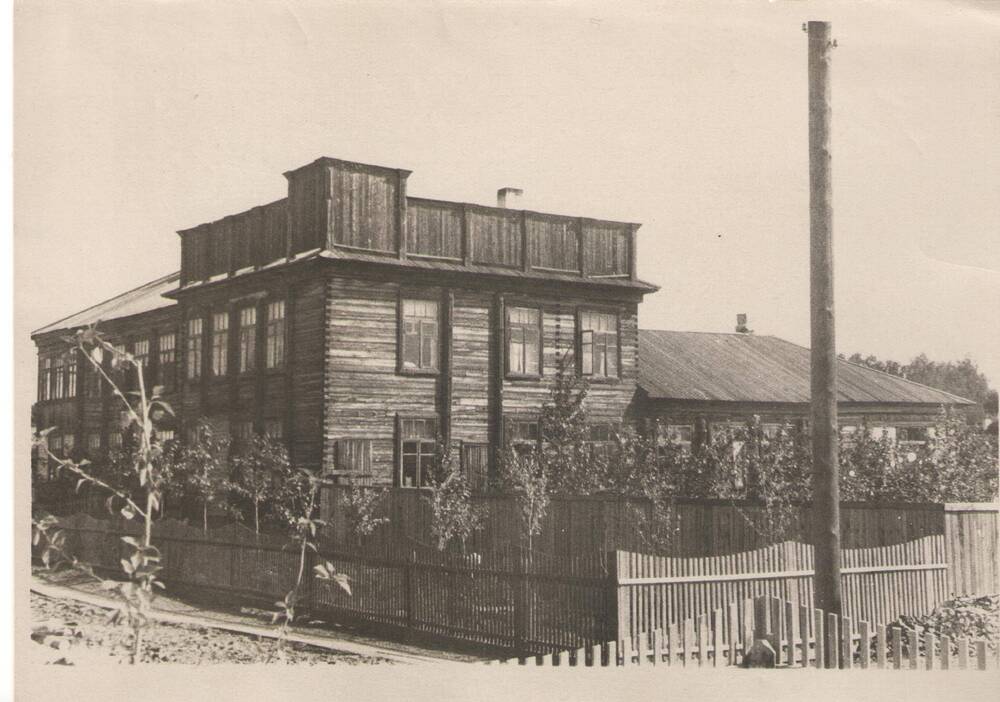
806,22,842,628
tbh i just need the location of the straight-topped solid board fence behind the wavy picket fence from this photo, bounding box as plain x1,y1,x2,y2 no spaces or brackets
323,486,1000,595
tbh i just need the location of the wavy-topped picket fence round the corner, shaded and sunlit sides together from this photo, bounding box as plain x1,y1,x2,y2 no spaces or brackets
43,515,988,653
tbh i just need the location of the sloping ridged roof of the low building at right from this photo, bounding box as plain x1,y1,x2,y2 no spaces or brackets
639,329,972,404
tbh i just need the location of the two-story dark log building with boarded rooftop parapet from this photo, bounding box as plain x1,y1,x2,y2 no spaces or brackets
33,158,656,486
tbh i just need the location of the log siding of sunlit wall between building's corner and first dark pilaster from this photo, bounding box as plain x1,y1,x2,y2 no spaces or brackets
323,275,440,482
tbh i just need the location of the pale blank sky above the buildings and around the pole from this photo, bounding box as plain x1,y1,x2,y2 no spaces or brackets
13,0,1000,417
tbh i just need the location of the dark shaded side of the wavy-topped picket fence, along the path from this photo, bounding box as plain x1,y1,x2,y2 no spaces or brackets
45,515,615,652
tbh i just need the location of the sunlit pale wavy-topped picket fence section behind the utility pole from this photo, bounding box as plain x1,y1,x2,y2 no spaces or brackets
612,536,948,639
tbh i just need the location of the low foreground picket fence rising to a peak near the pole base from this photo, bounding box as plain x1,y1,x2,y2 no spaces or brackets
496,596,1000,670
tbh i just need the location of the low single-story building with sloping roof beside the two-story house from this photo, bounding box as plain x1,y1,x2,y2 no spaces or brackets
630,329,975,442
